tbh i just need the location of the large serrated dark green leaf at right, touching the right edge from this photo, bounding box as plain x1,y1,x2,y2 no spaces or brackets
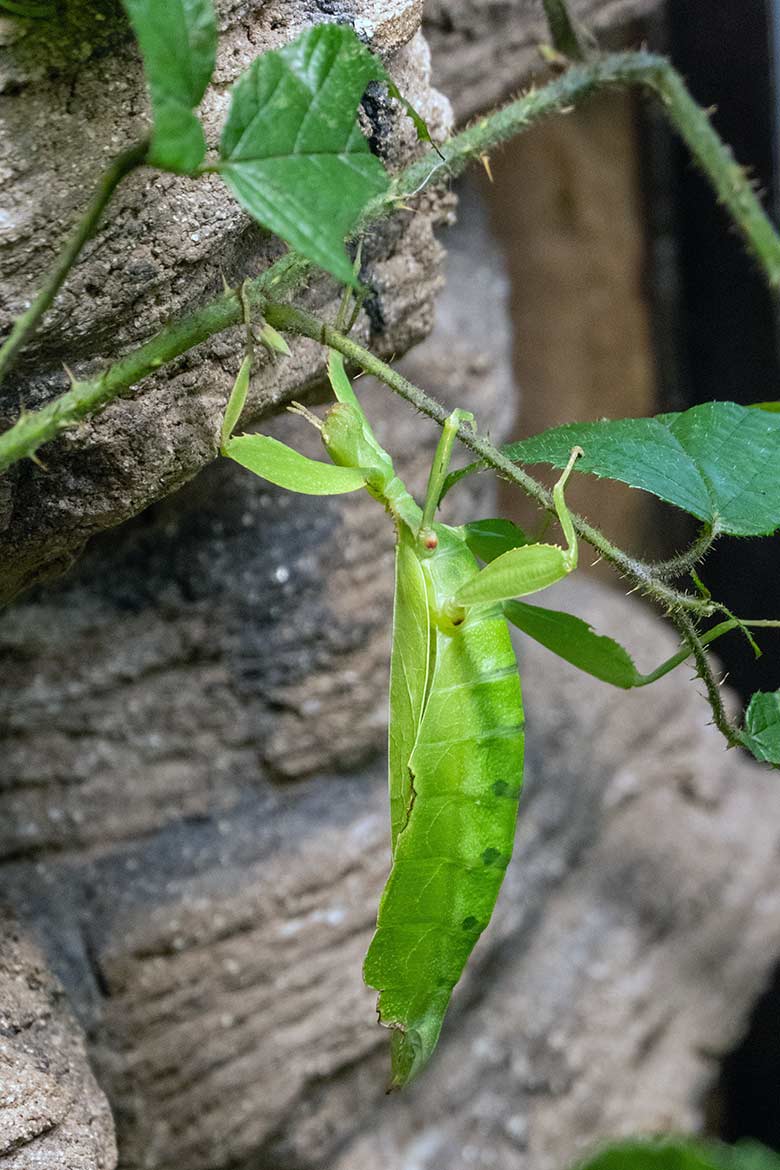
446,402,780,536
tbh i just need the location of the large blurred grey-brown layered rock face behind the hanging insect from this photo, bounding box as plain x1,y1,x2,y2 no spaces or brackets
0,182,780,1170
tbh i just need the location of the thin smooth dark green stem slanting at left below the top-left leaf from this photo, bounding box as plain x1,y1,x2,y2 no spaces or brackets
0,140,149,381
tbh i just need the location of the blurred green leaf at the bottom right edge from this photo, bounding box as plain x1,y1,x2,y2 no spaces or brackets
577,1138,780,1170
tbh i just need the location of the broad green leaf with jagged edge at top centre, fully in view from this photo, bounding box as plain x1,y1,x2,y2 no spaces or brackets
220,25,388,285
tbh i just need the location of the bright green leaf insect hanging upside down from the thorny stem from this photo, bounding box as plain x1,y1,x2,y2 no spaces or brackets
223,352,577,1087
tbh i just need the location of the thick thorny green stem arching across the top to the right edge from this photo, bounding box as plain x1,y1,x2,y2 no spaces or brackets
0,53,780,472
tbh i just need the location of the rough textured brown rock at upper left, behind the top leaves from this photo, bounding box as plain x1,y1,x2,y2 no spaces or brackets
0,0,450,601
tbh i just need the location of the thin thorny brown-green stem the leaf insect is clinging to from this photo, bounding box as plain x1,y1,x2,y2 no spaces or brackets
263,302,762,746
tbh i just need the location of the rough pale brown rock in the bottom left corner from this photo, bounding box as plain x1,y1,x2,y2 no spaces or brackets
0,909,117,1170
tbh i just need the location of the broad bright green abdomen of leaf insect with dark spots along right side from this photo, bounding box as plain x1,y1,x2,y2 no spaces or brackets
365,525,523,1085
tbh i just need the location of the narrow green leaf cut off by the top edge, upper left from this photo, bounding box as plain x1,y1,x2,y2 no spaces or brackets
123,0,216,174
